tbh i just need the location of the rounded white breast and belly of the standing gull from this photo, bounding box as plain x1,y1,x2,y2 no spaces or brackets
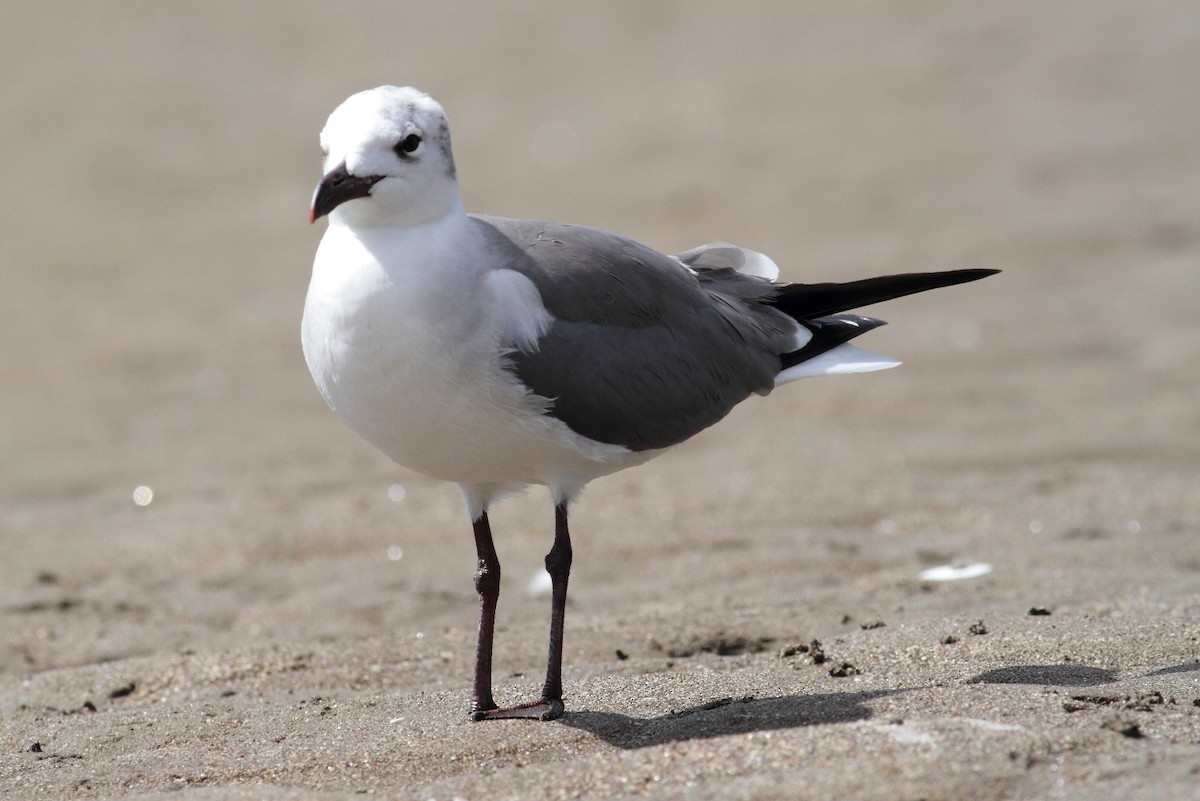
301,219,649,494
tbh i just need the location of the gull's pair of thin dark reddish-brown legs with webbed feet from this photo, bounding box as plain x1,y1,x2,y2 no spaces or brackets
472,501,571,721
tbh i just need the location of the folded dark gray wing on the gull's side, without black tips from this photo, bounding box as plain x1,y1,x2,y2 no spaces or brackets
472,217,797,451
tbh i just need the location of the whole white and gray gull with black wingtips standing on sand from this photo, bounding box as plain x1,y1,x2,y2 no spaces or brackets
301,86,996,719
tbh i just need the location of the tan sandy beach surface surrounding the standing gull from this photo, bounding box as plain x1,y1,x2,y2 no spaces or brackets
0,0,1200,801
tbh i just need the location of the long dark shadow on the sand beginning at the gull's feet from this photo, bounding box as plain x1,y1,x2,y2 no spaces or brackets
559,689,905,748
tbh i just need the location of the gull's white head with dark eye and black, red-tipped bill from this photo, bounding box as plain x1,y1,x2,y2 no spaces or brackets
310,86,460,227
